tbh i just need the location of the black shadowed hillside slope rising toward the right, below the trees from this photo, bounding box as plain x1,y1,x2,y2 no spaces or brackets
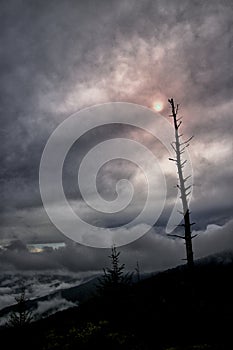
1,262,233,350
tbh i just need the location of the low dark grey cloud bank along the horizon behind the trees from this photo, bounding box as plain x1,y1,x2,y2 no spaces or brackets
0,220,233,274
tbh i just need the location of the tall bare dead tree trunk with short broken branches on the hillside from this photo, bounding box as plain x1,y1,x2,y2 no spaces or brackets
168,98,195,267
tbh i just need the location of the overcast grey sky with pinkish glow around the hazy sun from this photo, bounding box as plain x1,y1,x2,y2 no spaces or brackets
0,0,233,272
